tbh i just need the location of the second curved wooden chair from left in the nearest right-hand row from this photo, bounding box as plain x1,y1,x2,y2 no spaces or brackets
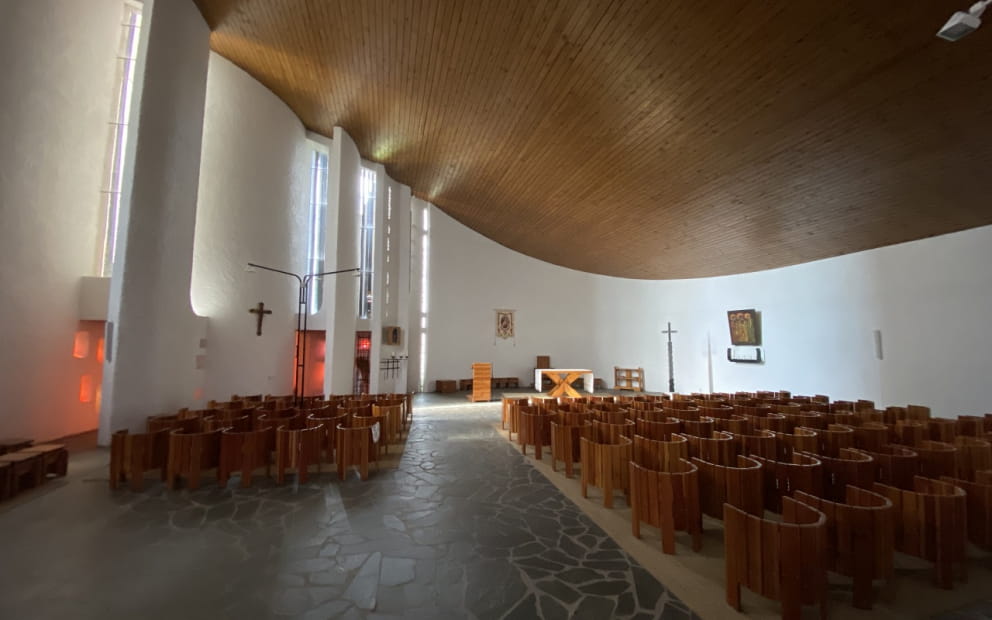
793,486,895,609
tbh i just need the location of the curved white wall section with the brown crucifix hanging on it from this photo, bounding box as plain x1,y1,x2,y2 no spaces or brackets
191,53,312,400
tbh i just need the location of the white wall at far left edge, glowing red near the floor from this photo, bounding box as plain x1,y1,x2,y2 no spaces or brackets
0,0,122,440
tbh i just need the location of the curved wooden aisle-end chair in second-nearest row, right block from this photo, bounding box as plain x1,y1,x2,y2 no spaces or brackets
630,450,703,554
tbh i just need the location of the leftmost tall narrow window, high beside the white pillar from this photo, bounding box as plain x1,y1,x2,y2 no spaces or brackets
100,0,141,276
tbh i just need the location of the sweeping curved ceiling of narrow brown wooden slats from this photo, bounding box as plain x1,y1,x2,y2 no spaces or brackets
196,0,992,278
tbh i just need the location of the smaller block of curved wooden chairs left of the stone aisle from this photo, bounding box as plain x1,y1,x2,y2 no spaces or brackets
110,397,411,490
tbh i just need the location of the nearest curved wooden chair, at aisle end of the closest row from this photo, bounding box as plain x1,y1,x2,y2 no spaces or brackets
723,497,827,620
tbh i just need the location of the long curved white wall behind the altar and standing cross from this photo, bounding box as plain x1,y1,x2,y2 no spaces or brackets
426,209,992,416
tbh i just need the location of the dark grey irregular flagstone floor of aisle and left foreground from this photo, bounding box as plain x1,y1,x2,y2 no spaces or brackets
0,394,692,620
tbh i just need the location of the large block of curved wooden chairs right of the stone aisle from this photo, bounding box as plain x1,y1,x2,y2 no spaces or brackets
503,398,992,617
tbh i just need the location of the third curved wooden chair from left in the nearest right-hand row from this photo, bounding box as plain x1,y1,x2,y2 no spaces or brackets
874,476,968,590
